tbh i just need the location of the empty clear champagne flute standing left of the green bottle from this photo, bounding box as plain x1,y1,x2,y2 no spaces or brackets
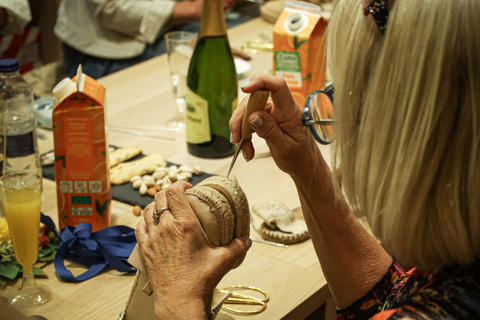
165,31,197,127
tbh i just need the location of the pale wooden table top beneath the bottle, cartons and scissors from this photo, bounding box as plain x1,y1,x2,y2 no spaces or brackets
0,18,332,320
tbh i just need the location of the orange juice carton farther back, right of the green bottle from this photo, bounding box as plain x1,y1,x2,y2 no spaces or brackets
273,1,327,108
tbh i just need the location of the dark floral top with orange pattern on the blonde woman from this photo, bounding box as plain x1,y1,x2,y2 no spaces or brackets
337,260,480,320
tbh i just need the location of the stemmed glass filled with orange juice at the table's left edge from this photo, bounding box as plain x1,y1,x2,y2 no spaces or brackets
0,172,52,305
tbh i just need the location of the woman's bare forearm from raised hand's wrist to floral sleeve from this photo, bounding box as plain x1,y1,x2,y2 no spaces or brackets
293,140,392,308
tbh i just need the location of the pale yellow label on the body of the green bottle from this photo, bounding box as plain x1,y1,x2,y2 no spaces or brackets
185,87,212,144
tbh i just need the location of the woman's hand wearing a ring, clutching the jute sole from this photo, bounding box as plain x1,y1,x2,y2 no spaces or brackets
136,181,251,319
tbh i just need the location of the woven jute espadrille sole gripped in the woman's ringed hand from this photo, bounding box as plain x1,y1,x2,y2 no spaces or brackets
120,176,250,320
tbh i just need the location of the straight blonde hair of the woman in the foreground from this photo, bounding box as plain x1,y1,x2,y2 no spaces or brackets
328,0,480,269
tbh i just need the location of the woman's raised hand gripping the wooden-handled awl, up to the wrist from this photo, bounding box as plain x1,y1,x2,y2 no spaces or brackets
230,73,319,177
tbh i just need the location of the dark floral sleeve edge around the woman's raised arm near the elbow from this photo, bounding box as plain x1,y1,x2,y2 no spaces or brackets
337,261,406,320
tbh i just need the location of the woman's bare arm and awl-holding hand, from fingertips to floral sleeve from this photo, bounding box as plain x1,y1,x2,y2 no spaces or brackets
230,74,392,308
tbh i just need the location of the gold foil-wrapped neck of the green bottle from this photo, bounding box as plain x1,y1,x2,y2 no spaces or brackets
198,0,227,39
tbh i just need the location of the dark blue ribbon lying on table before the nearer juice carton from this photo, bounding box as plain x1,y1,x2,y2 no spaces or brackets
53,223,137,282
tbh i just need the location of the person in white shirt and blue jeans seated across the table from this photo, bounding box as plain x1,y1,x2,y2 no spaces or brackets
54,0,251,78
